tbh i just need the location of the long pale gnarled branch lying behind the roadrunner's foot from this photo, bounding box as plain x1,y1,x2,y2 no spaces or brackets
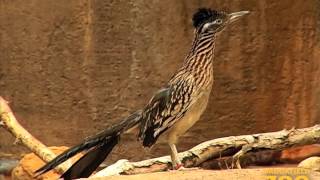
93,125,320,177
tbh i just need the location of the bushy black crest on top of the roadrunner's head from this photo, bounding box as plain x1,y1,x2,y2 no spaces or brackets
192,8,220,28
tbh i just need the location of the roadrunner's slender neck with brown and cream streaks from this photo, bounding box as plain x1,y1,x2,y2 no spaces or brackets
184,33,215,71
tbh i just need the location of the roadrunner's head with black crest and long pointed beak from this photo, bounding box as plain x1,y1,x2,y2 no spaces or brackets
192,8,249,33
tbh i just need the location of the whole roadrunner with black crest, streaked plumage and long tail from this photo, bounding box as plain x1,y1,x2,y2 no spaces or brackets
36,9,248,179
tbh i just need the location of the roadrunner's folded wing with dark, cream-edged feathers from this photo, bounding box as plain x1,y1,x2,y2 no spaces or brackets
139,74,194,146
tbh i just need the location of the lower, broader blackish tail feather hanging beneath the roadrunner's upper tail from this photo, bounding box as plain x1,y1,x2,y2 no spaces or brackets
61,135,120,180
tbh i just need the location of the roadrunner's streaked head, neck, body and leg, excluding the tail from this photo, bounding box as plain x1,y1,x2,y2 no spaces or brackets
139,9,246,168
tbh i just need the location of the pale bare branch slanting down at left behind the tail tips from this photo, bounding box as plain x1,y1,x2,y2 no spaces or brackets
0,96,69,173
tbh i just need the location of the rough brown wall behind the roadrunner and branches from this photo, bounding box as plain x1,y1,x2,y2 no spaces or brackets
0,0,320,161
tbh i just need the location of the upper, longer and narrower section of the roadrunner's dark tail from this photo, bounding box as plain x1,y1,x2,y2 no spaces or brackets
35,110,142,176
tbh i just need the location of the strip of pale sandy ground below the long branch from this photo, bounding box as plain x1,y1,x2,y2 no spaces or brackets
90,168,320,180
